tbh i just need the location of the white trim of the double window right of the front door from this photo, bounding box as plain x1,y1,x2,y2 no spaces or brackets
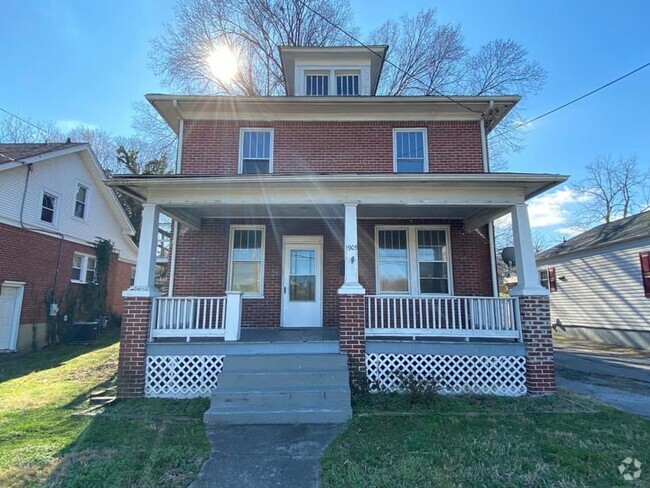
375,225,454,297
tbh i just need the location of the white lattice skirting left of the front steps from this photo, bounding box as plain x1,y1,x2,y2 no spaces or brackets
144,355,225,398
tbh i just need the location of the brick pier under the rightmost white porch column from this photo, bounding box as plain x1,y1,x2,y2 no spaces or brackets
519,296,555,395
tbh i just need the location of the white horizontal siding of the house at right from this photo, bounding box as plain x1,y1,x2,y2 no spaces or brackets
538,239,650,347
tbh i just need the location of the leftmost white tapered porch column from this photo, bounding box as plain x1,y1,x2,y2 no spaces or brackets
122,203,160,297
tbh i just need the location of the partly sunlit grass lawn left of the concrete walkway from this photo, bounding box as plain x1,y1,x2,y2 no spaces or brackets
0,333,209,488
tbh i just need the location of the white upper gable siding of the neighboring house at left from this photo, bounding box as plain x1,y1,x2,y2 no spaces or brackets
0,152,137,262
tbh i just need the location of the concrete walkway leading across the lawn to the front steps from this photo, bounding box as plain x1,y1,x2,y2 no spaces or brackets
190,424,345,488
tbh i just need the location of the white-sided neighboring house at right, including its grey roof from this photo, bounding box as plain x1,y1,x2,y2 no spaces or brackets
537,212,650,349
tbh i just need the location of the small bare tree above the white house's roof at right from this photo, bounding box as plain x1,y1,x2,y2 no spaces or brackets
571,155,650,230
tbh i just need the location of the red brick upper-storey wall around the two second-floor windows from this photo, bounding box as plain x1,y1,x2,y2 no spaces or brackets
181,120,483,175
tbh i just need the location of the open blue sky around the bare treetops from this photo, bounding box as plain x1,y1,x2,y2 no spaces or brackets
0,0,650,239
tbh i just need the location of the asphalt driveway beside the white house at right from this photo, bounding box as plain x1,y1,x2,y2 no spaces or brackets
554,337,650,419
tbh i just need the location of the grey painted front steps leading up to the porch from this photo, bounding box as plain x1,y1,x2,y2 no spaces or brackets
204,354,352,425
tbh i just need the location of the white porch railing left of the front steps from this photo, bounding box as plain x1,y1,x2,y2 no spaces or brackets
150,292,241,342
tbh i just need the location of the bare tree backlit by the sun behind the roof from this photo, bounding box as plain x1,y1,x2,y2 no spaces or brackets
150,0,354,96
